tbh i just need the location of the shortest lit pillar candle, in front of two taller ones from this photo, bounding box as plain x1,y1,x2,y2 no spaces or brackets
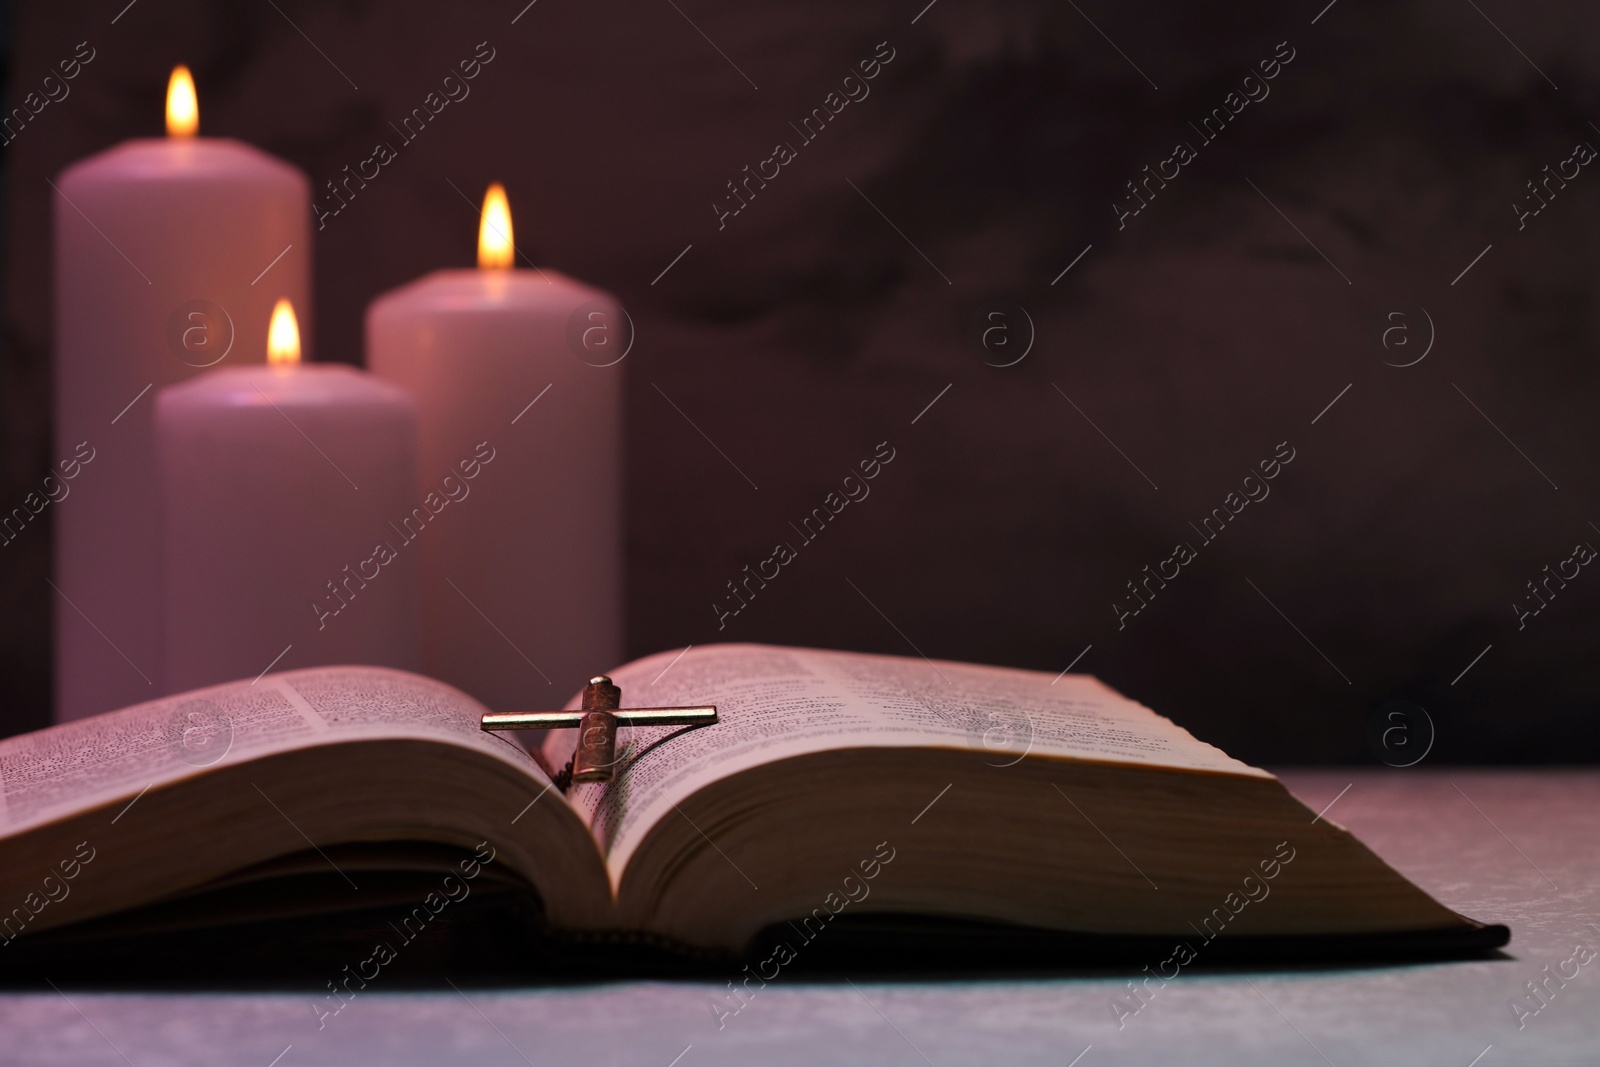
155,301,419,689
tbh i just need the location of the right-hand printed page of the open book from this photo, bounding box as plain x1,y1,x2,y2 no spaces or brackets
544,645,1272,888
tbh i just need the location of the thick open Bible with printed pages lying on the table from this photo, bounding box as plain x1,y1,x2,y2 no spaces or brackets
0,645,1509,979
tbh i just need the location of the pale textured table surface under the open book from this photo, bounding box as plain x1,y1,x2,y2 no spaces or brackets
0,769,1600,1067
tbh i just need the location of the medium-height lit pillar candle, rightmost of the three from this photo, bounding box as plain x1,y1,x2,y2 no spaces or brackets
366,186,629,709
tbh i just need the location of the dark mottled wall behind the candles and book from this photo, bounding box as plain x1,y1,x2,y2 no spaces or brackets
0,0,1600,761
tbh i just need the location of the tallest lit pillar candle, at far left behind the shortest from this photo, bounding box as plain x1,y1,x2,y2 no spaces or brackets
54,69,310,720
